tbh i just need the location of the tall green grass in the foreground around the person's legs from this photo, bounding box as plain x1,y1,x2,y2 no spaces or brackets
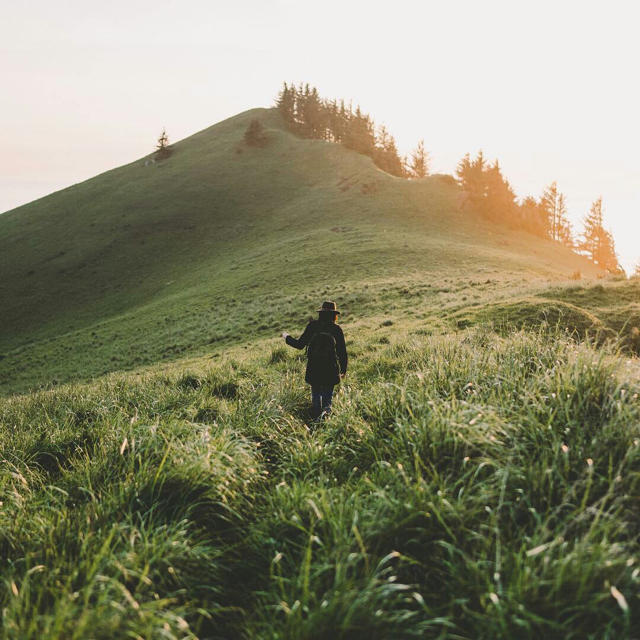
0,327,640,640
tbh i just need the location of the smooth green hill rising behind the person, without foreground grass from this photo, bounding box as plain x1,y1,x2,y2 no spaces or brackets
0,109,597,391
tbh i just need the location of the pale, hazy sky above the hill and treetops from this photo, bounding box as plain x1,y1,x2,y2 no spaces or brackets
0,0,640,270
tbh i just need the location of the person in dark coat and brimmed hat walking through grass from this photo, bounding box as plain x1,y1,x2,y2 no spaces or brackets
282,301,347,418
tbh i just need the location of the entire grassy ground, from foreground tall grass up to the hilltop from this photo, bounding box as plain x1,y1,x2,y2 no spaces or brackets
0,110,640,640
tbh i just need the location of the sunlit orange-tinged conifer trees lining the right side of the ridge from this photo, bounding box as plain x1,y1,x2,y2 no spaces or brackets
276,82,622,273
